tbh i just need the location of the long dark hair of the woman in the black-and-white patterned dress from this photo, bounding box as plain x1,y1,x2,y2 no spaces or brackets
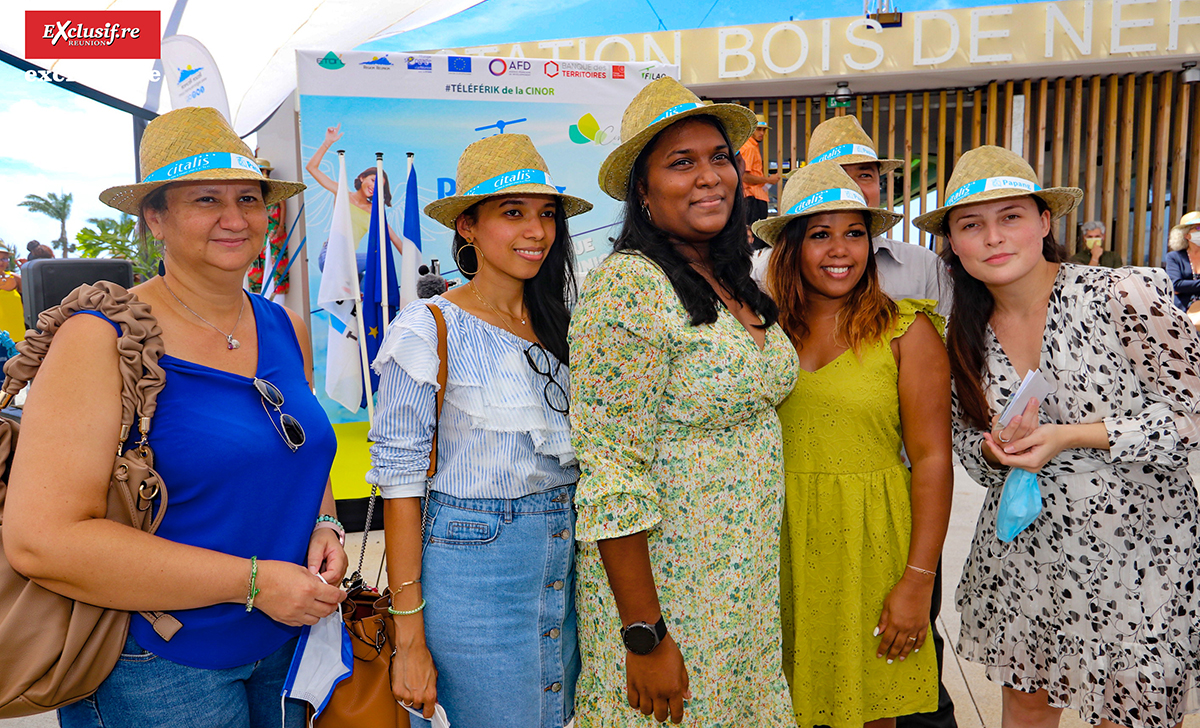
942,195,1067,431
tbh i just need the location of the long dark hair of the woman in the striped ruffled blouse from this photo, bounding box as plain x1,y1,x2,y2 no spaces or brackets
452,203,575,365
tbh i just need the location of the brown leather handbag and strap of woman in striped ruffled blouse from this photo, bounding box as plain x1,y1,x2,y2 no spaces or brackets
317,303,448,728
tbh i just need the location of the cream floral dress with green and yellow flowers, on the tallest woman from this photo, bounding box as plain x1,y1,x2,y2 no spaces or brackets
570,253,798,728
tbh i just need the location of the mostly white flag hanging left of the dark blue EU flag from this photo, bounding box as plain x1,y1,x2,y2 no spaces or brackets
317,155,362,413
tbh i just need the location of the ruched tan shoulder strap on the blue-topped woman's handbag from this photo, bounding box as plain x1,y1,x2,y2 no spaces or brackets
0,281,167,451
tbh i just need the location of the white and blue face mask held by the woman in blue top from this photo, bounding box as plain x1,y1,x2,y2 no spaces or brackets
283,610,354,720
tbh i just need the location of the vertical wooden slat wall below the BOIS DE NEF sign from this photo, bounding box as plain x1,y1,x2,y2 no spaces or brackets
740,67,1200,265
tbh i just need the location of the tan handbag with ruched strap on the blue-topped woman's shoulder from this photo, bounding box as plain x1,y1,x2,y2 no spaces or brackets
0,282,181,718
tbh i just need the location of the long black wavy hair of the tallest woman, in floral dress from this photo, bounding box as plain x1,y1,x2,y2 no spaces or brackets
612,114,779,329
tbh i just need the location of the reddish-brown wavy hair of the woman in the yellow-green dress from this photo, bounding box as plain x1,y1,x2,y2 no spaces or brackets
767,212,900,354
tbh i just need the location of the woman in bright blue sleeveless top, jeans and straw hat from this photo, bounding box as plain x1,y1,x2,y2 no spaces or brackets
4,103,347,728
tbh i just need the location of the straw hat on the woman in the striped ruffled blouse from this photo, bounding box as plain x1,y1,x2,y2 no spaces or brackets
425,134,592,230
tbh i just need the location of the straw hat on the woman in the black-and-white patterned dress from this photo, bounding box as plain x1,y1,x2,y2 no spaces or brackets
912,146,1084,235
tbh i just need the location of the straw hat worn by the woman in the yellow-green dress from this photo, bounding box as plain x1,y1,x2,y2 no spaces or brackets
752,162,904,246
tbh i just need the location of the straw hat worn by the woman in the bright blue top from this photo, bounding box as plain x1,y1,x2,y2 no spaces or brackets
100,107,305,215
